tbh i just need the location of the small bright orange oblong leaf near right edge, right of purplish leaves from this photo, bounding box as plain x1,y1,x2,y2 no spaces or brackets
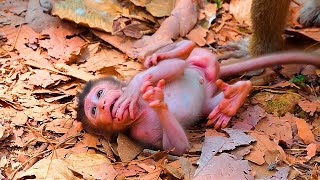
294,118,316,144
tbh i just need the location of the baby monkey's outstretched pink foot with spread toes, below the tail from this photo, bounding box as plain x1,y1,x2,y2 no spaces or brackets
207,79,252,129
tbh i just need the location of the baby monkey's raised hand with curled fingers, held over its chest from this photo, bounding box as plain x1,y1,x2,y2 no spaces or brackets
140,76,168,110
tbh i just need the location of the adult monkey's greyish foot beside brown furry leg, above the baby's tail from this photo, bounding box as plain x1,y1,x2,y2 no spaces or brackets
218,37,250,60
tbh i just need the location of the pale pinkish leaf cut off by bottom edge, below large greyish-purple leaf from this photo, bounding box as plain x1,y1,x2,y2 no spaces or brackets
193,153,254,180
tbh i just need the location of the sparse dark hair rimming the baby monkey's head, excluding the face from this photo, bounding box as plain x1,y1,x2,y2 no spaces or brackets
76,76,123,135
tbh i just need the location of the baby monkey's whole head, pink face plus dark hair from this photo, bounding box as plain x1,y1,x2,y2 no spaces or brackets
77,76,128,135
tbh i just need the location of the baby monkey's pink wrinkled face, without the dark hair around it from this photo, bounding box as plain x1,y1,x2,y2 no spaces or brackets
84,81,130,131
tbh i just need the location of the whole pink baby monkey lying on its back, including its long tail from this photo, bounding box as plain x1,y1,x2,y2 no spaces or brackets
77,40,320,155
